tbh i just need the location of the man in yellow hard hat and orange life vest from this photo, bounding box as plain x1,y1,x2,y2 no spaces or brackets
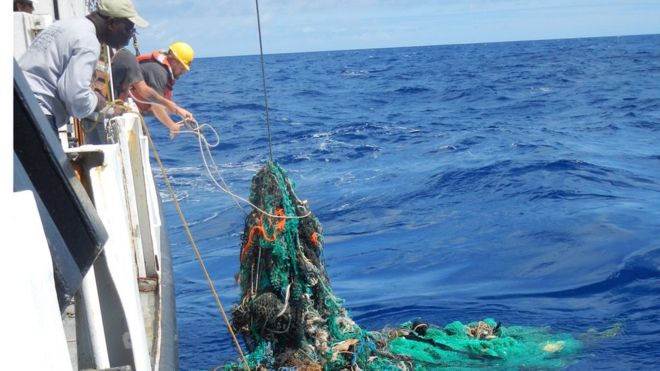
131,41,195,138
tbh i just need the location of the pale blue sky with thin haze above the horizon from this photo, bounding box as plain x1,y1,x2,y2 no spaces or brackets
134,0,660,57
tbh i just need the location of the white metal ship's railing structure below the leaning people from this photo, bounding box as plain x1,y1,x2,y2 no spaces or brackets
66,113,161,370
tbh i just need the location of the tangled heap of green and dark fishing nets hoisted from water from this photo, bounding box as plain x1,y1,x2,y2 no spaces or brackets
225,162,580,370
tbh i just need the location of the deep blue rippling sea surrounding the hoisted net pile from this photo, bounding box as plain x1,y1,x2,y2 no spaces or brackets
150,35,660,370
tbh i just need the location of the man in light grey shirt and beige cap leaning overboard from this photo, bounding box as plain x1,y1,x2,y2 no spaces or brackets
19,0,149,132
